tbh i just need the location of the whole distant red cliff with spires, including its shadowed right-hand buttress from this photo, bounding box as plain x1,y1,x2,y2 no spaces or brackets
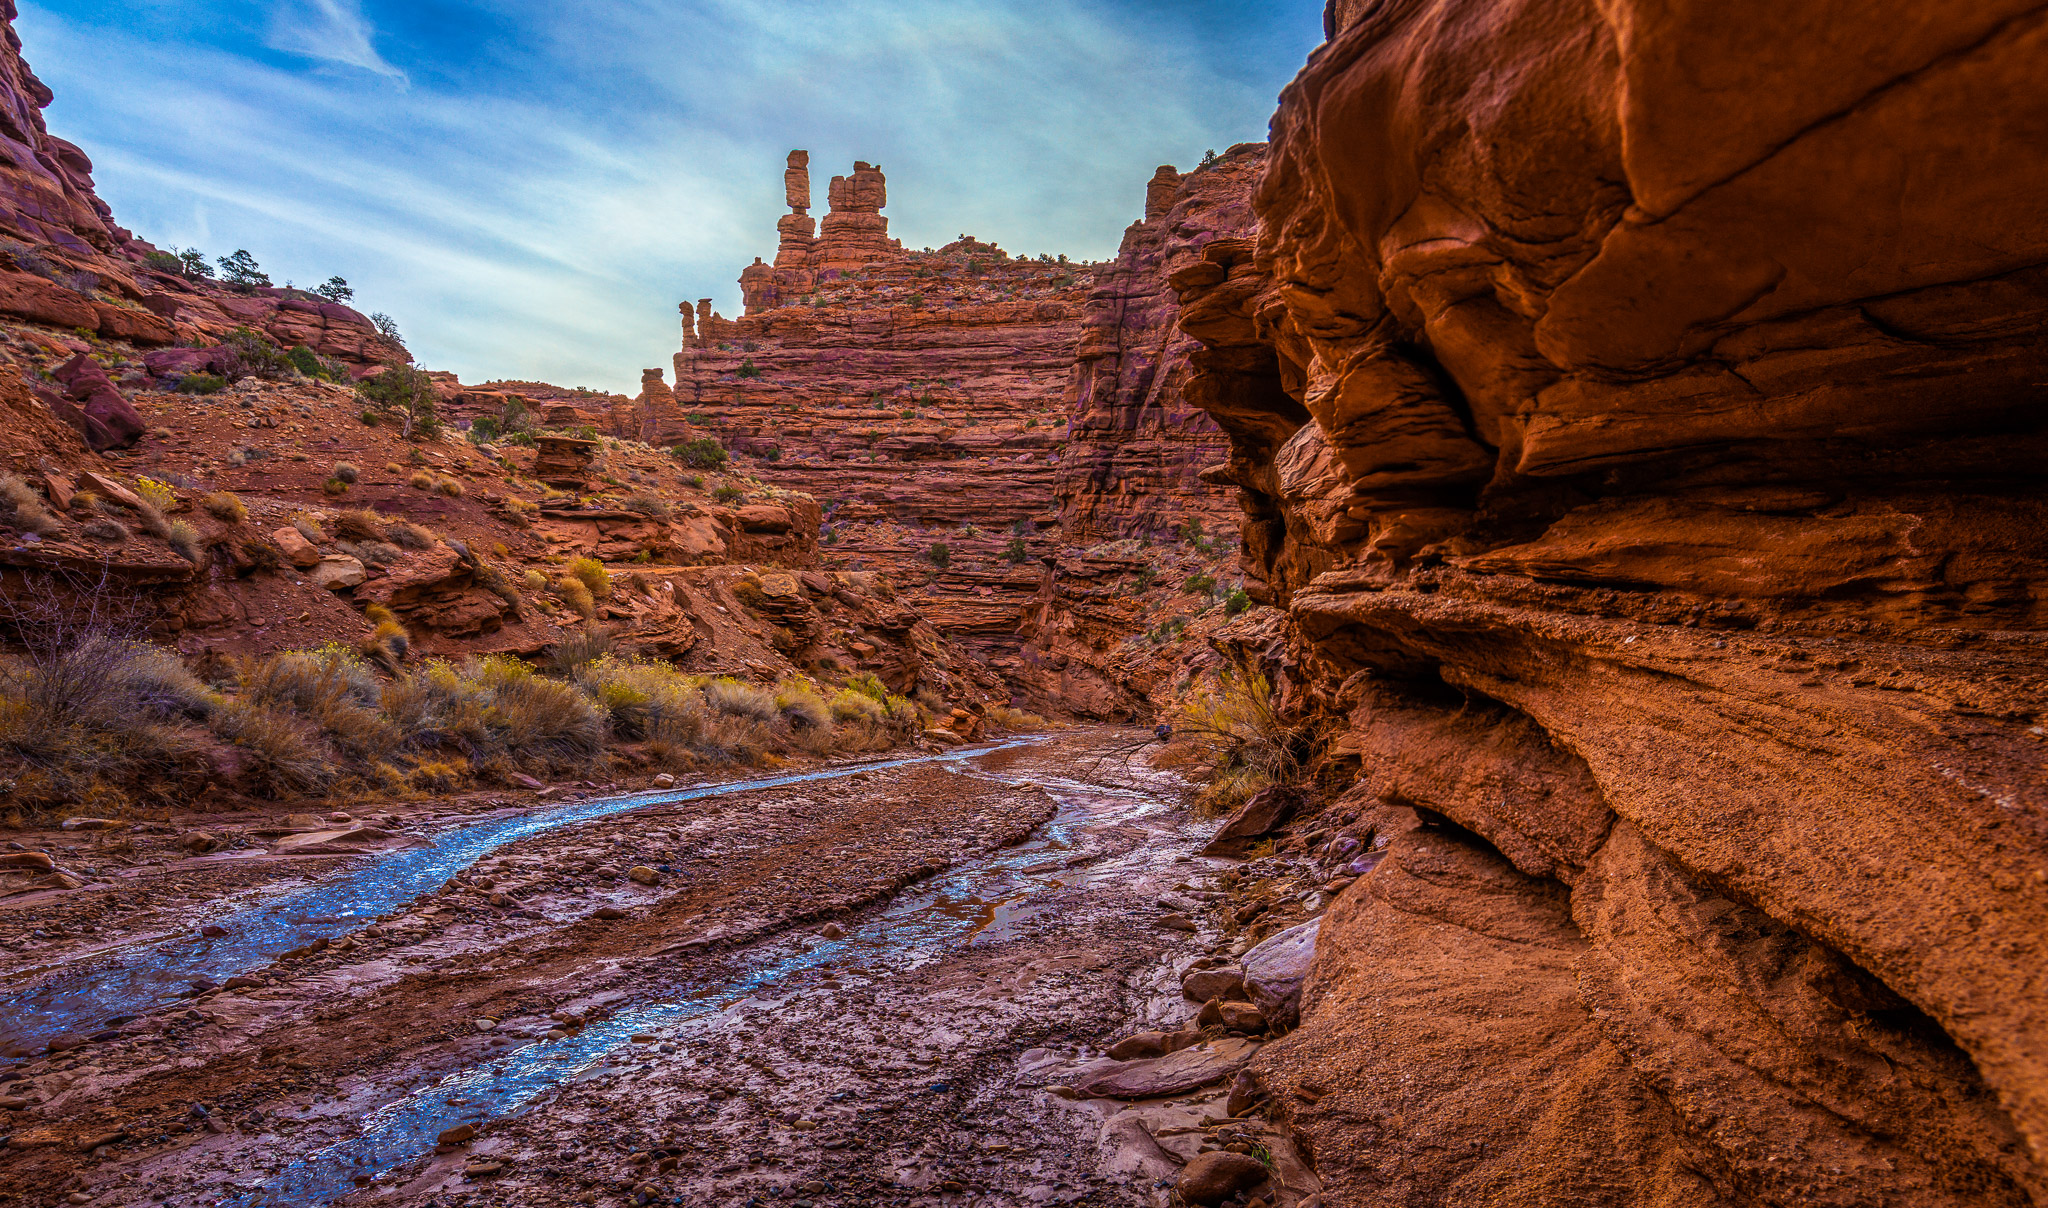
606,156,1257,713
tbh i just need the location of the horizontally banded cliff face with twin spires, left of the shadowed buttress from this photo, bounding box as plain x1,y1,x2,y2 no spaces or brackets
608,161,1092,687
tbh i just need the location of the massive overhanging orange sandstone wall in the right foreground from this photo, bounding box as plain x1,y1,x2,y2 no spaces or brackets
1174,0,2048,1204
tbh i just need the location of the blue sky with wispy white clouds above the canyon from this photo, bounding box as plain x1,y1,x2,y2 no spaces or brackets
16,0,1323,393
